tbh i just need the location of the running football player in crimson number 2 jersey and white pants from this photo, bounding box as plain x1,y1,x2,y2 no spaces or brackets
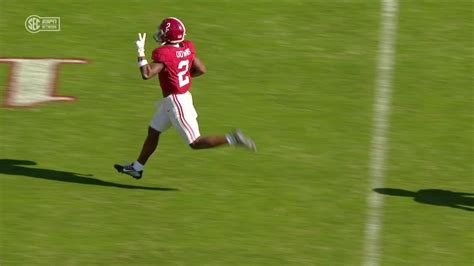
114,17,255,179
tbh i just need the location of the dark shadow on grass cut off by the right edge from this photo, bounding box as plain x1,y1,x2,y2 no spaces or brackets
374,188,474,211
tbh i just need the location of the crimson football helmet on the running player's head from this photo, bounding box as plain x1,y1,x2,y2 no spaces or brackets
153,17,186,44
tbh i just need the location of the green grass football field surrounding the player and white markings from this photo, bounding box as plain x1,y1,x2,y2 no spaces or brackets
0,0,474,266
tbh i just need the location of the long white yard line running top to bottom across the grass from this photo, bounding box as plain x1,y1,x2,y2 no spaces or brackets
363,0,398,266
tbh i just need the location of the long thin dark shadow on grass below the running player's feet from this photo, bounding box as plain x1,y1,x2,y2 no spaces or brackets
0,159,178,191
